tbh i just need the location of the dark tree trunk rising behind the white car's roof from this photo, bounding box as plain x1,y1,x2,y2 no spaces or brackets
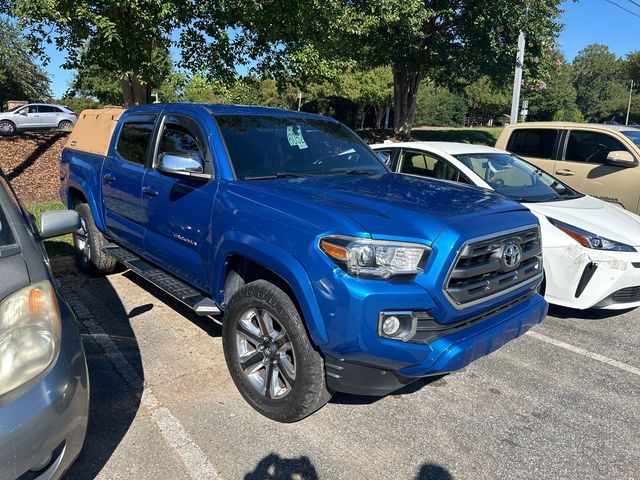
393,67,422,137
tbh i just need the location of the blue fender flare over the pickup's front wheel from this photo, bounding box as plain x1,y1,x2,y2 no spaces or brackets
213,231,328,346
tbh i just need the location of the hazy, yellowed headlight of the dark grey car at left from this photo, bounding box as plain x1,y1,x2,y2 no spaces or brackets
0,281,62,395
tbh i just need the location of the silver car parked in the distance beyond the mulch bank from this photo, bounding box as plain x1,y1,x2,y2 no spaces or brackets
0,103,78,135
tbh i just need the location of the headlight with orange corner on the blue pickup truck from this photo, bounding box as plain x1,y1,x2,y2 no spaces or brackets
320,235,431,279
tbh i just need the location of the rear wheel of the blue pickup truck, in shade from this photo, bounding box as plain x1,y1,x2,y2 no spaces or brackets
73,203,118,275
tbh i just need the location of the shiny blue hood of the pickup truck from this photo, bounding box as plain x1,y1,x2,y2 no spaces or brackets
236,173,524,241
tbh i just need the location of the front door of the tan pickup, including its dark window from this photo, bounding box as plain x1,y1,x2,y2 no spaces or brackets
556,128,640,212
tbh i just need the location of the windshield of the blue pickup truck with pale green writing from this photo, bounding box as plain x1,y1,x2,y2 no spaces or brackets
216,115,388,180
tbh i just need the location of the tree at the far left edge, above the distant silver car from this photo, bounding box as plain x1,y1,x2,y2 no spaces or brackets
0,18,51,110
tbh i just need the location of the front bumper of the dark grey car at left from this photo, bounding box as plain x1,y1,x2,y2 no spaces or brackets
0,298,89,480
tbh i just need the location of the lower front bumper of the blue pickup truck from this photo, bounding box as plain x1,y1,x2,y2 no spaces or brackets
326,288,548,395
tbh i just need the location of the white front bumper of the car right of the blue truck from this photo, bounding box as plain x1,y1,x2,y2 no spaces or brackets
544,246,640,310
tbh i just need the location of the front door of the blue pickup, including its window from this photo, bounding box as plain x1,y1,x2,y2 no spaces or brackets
142,114,218,291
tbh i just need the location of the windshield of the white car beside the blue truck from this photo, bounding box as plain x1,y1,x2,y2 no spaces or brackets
455,152,581,202
